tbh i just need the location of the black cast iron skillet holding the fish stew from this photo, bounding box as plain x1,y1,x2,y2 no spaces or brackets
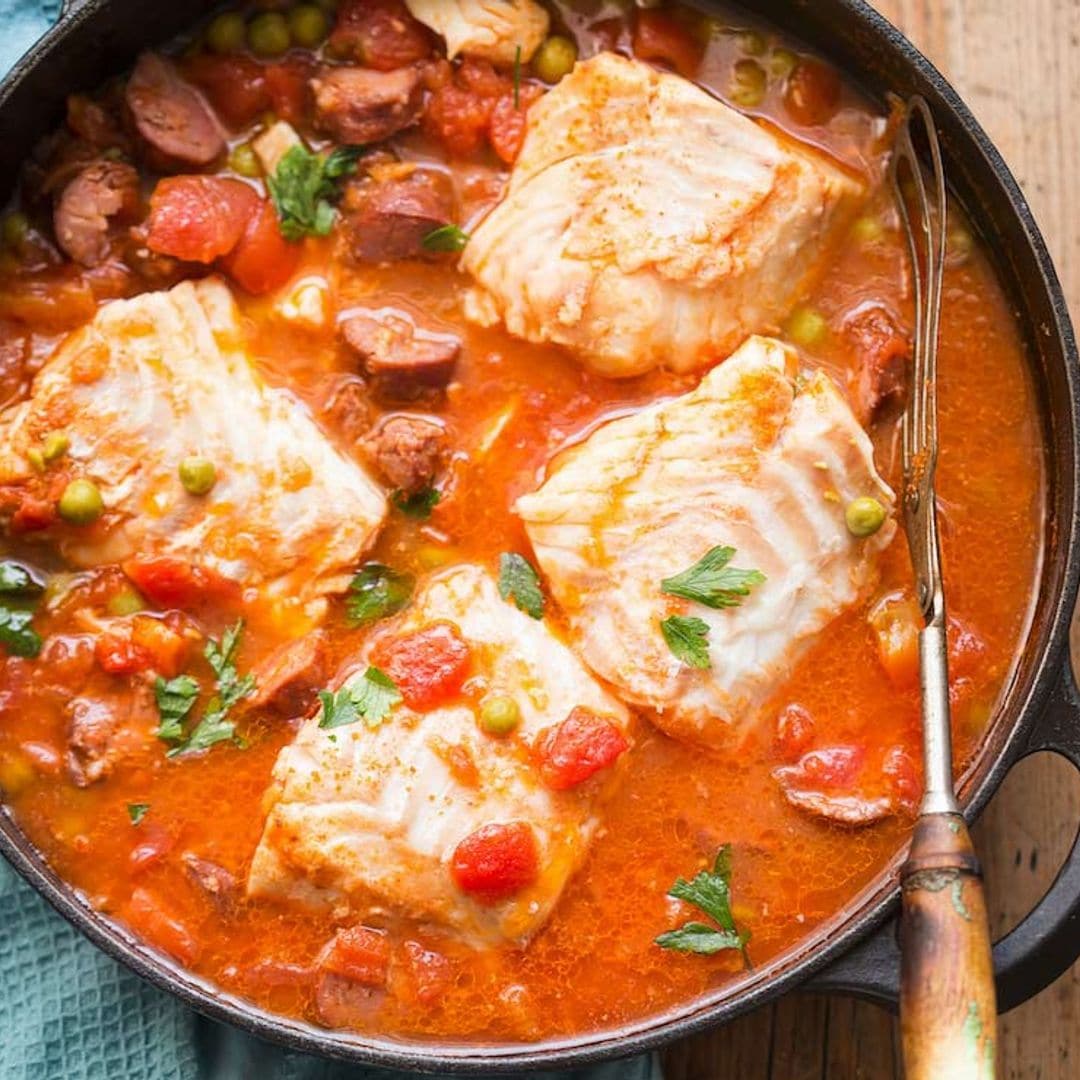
0,0,1080,1072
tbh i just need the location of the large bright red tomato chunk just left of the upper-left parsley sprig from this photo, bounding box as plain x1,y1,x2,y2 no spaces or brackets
147,176,259,262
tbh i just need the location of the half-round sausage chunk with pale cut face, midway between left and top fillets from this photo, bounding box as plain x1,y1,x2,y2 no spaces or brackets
341,313,461,393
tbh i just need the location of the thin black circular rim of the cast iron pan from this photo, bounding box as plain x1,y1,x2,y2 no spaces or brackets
0,0,1080,1075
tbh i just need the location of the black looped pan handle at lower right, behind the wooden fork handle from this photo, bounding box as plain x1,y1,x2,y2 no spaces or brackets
802,658,1080,1013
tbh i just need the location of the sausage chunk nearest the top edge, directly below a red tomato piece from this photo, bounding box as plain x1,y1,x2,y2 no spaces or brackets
311,67,423,145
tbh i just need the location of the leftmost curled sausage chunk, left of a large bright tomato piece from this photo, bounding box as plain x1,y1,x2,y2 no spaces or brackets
53,161,139,267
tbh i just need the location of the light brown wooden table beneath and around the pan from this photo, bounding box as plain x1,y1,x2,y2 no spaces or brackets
666,0,1080,1080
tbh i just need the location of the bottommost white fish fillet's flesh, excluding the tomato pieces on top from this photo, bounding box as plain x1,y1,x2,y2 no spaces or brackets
248,566,630,944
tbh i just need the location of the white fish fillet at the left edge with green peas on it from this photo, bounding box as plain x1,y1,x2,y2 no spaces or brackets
0,279,387,617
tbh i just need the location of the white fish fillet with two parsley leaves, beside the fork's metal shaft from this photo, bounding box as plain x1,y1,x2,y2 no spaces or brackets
516,338,895,746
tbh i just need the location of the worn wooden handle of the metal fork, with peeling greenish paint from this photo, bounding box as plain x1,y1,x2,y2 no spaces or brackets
900,813,997,1080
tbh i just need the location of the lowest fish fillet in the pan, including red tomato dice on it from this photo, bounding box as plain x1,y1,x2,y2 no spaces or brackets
248,565,630,944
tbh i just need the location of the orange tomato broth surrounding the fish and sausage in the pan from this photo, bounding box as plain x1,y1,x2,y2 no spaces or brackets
0,4,1043,1040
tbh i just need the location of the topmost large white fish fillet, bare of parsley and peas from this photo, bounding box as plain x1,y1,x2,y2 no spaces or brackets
462,53,862,376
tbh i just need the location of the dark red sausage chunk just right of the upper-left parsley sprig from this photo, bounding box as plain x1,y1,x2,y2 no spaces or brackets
342,173,453,262
